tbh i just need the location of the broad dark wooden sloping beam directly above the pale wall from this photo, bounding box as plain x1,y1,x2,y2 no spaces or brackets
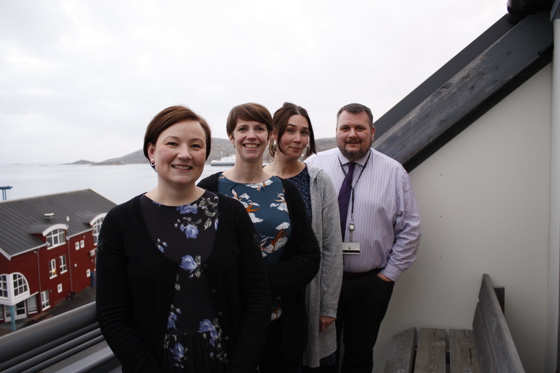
373,7,553,171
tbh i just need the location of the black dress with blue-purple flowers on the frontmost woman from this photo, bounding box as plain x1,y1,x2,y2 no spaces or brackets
140,191,228,372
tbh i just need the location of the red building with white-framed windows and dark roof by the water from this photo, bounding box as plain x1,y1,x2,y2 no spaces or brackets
0,189,116,323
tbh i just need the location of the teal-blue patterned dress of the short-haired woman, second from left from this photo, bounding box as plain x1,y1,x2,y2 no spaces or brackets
218,174,292,321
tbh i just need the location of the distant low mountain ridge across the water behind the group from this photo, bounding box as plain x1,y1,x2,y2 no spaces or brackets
72,137,336,166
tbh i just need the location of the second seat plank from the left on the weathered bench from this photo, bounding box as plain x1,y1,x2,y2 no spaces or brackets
414,329,447,373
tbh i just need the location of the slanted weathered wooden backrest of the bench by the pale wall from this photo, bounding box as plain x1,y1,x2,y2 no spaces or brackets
478,274,525,373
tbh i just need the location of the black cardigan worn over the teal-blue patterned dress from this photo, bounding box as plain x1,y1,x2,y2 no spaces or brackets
198,172,321,356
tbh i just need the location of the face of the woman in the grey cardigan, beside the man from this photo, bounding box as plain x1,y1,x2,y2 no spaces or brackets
275,114,309,159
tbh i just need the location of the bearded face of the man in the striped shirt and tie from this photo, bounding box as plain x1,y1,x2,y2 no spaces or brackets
336,111,375,161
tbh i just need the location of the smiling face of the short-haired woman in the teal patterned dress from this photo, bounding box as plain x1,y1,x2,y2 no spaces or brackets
230,119,269,163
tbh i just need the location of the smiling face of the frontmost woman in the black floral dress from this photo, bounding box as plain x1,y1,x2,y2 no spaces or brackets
148,120,206,186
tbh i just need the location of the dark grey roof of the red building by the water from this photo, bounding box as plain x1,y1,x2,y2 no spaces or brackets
0,189,116,257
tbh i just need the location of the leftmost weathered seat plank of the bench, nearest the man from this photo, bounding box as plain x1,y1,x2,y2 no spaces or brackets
384,328,416,373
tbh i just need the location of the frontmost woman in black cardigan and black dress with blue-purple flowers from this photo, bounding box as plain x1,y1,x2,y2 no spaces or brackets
96,106,270,372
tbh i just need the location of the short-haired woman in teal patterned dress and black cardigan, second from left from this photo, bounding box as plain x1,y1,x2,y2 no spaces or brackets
199,103,320,373
